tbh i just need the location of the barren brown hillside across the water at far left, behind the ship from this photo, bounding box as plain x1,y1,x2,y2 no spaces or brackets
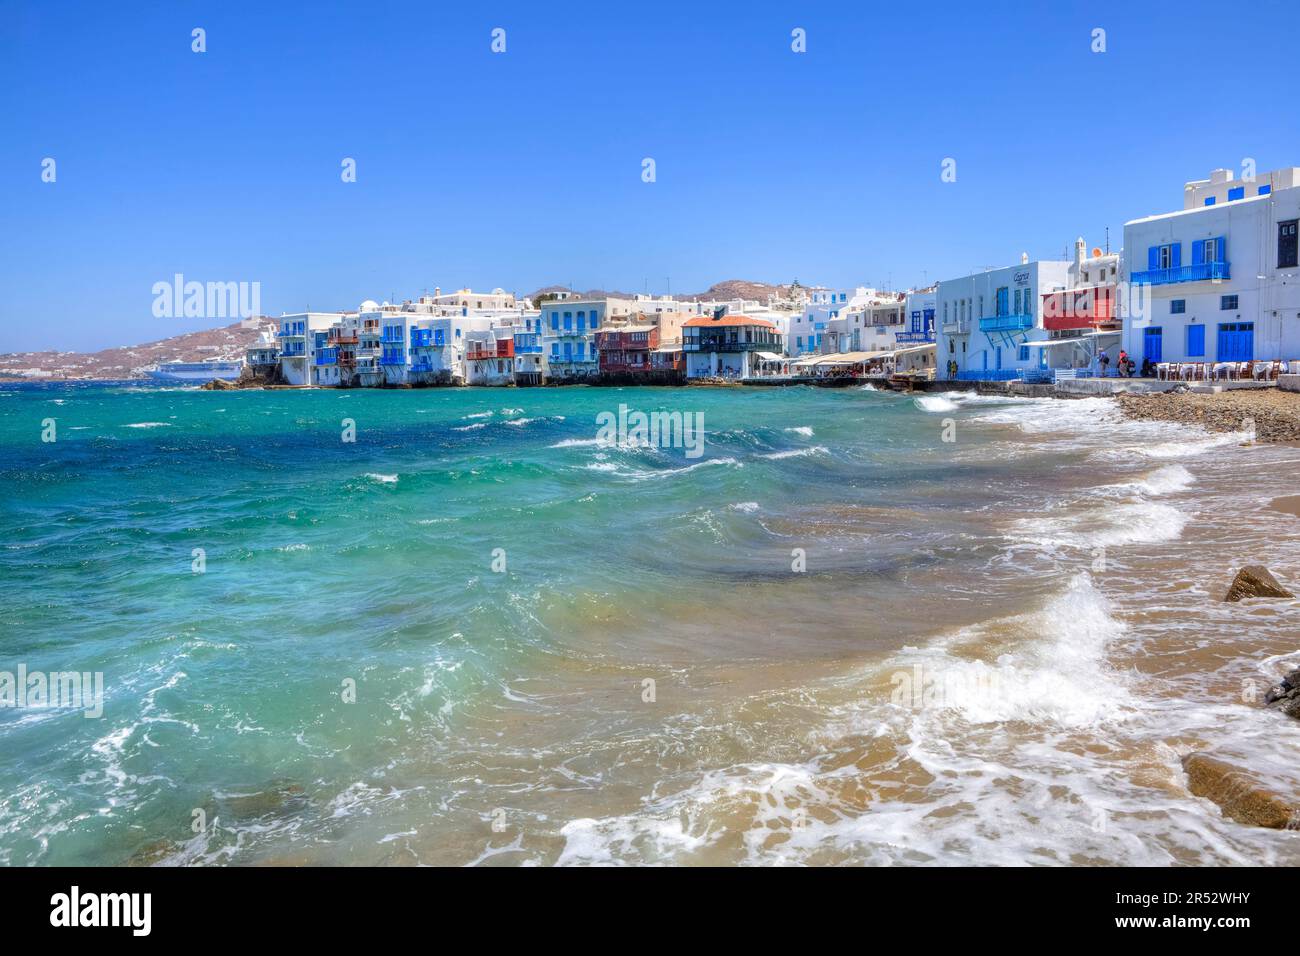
0,320,272,381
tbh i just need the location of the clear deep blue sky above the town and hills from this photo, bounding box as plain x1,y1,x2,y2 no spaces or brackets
0,0,1300,351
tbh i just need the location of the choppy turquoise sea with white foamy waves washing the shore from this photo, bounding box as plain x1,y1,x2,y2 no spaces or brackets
0,385,1300,865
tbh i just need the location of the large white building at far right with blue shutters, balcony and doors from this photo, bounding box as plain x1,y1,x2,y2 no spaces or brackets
1122,166,1300,365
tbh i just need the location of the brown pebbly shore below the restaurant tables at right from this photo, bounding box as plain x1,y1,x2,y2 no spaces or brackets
1115,389,1300,442
